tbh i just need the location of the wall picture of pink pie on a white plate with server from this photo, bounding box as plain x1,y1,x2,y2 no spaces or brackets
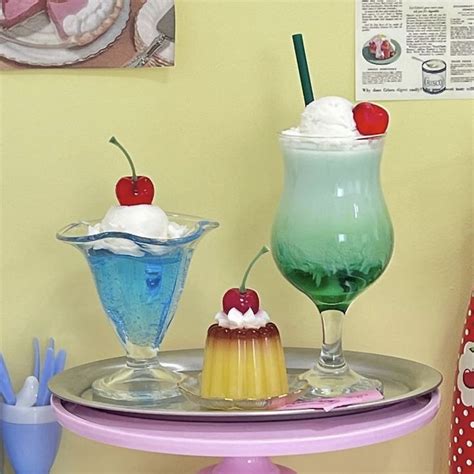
0,0,175,69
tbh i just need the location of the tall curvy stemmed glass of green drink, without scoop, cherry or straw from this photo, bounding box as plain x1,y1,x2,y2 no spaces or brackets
272,133,393,397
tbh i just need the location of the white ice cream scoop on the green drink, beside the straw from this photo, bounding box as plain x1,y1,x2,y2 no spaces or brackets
298,96,360,138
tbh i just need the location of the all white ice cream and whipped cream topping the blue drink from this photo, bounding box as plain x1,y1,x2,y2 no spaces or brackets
89,204,189,256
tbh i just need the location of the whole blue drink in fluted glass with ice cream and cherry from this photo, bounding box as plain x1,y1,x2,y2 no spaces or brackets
58,138,218,405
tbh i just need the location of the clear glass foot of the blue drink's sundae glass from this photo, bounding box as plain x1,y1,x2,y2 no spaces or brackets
92,365,185,405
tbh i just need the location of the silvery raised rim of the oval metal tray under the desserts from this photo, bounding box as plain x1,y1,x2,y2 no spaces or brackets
49,347,443,422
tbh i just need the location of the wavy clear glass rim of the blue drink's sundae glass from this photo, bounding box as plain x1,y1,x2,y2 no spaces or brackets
56,211,219,247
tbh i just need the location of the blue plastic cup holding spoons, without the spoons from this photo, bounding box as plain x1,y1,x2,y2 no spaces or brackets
2,404,62,474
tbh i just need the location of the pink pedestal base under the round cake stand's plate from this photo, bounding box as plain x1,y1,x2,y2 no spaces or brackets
198,457,297,474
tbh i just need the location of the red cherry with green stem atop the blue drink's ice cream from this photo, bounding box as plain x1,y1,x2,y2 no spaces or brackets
109,137,155,206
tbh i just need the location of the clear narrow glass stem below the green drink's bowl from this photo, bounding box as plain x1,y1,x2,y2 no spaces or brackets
318,310,346,370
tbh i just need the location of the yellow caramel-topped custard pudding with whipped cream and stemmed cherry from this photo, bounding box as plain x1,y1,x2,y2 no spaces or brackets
201,247,288,400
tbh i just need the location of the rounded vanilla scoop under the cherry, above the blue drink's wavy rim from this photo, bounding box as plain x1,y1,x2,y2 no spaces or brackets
94,204,169,239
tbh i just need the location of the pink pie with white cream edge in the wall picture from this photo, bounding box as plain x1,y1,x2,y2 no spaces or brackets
0,0,123,46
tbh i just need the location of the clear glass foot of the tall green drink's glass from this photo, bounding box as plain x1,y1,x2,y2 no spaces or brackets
299,364,383,400
